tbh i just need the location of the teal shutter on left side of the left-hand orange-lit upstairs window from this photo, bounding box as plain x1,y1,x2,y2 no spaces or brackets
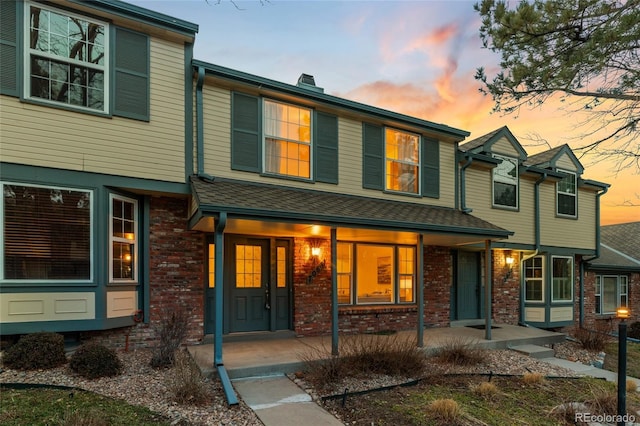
231,93,262,172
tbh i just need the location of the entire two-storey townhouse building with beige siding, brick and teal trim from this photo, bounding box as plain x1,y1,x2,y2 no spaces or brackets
0,0,608,344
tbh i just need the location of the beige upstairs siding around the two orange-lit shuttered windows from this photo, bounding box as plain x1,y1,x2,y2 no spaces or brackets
203,85,455,207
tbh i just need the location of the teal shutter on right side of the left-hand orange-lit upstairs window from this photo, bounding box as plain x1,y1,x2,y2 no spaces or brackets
313,112,338,184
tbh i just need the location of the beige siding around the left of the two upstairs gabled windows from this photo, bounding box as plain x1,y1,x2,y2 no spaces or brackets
465,167,535,244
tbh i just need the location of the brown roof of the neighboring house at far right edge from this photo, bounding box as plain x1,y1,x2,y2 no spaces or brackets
590,222,640,271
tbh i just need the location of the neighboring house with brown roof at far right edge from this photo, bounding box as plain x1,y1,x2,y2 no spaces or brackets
585,222,640,322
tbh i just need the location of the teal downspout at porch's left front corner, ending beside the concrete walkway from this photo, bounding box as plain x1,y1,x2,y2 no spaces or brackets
213,212,238,405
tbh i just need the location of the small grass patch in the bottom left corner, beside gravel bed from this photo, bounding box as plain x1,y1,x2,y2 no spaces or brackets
0,386,171,426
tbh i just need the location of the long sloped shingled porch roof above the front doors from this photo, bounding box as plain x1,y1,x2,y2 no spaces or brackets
191,176,513,239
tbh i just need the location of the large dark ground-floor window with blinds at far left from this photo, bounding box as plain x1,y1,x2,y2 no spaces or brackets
0,183,93,282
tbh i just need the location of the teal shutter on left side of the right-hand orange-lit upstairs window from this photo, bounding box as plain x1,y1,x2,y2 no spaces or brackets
362,123,384,190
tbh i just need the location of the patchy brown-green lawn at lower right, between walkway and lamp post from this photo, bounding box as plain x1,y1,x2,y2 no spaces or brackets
325,375,640,426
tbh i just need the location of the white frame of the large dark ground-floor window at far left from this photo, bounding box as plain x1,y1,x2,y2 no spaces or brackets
0,181,95,284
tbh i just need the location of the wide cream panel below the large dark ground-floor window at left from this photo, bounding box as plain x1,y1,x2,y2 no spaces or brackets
0,292,95,323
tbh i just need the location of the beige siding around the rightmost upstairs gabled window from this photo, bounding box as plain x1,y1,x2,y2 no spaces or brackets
540,183,598,250
